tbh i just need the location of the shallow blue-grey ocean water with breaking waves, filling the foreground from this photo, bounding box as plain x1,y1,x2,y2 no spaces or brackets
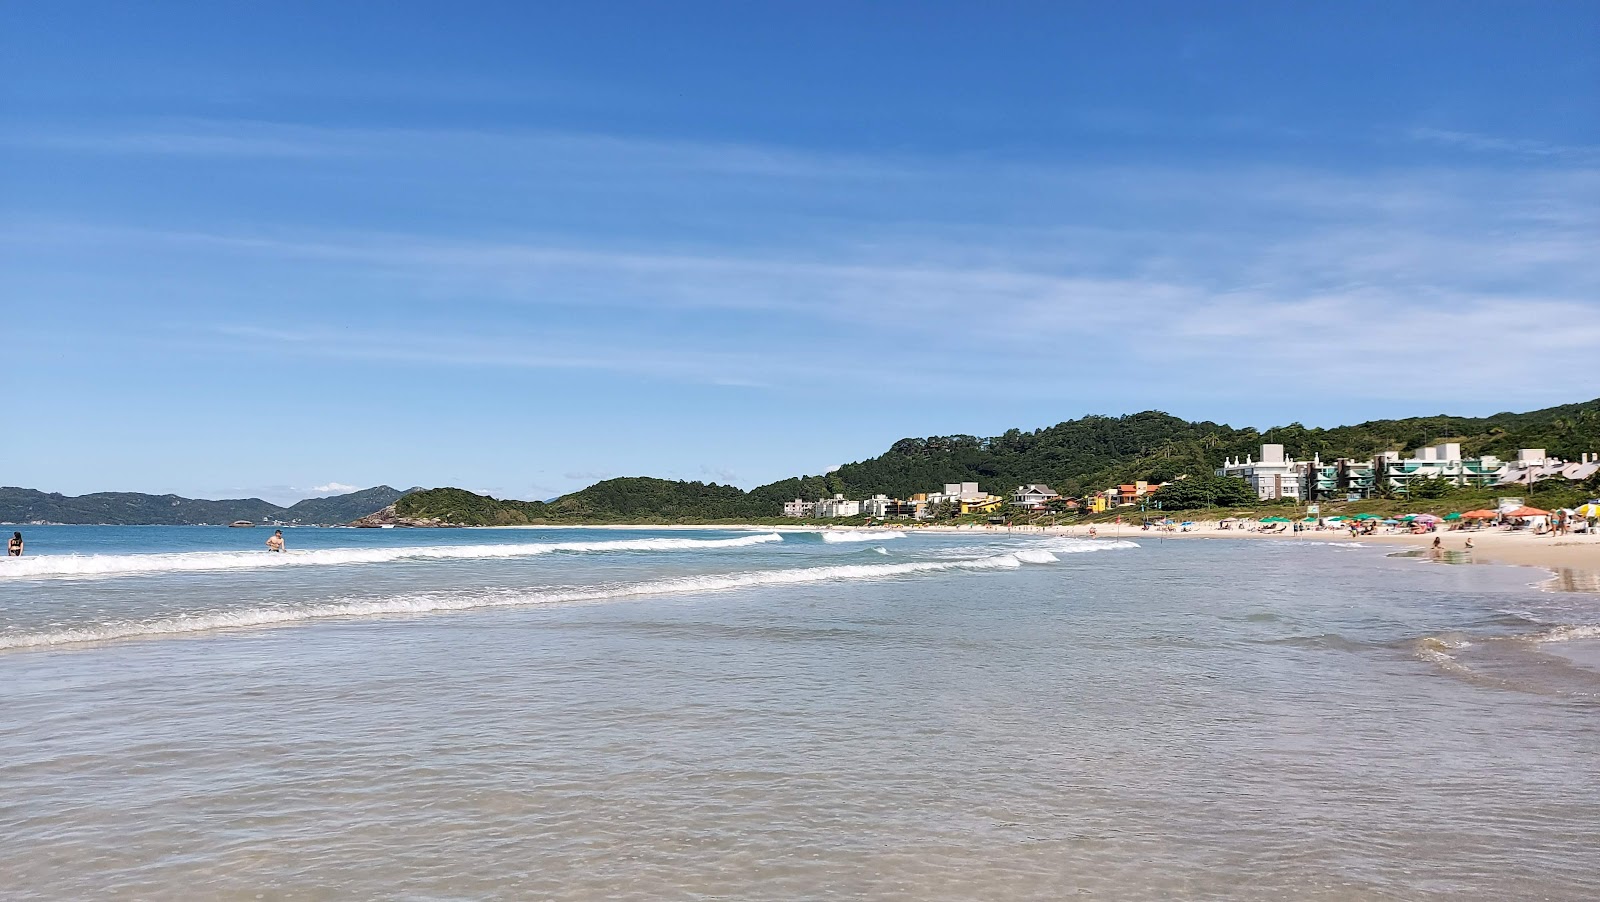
0,526,1600,900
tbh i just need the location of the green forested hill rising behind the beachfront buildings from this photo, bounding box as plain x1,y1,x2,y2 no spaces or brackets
397,400,1600,525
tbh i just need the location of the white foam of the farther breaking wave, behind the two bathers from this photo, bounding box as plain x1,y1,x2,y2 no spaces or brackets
0,533,784,579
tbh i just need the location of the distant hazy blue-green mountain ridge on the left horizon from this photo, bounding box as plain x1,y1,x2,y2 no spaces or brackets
0,486,421,526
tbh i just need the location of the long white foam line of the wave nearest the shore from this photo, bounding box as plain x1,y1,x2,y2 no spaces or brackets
0,552,1056,649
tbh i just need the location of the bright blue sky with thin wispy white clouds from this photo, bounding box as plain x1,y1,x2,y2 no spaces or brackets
0,2,1600,501
